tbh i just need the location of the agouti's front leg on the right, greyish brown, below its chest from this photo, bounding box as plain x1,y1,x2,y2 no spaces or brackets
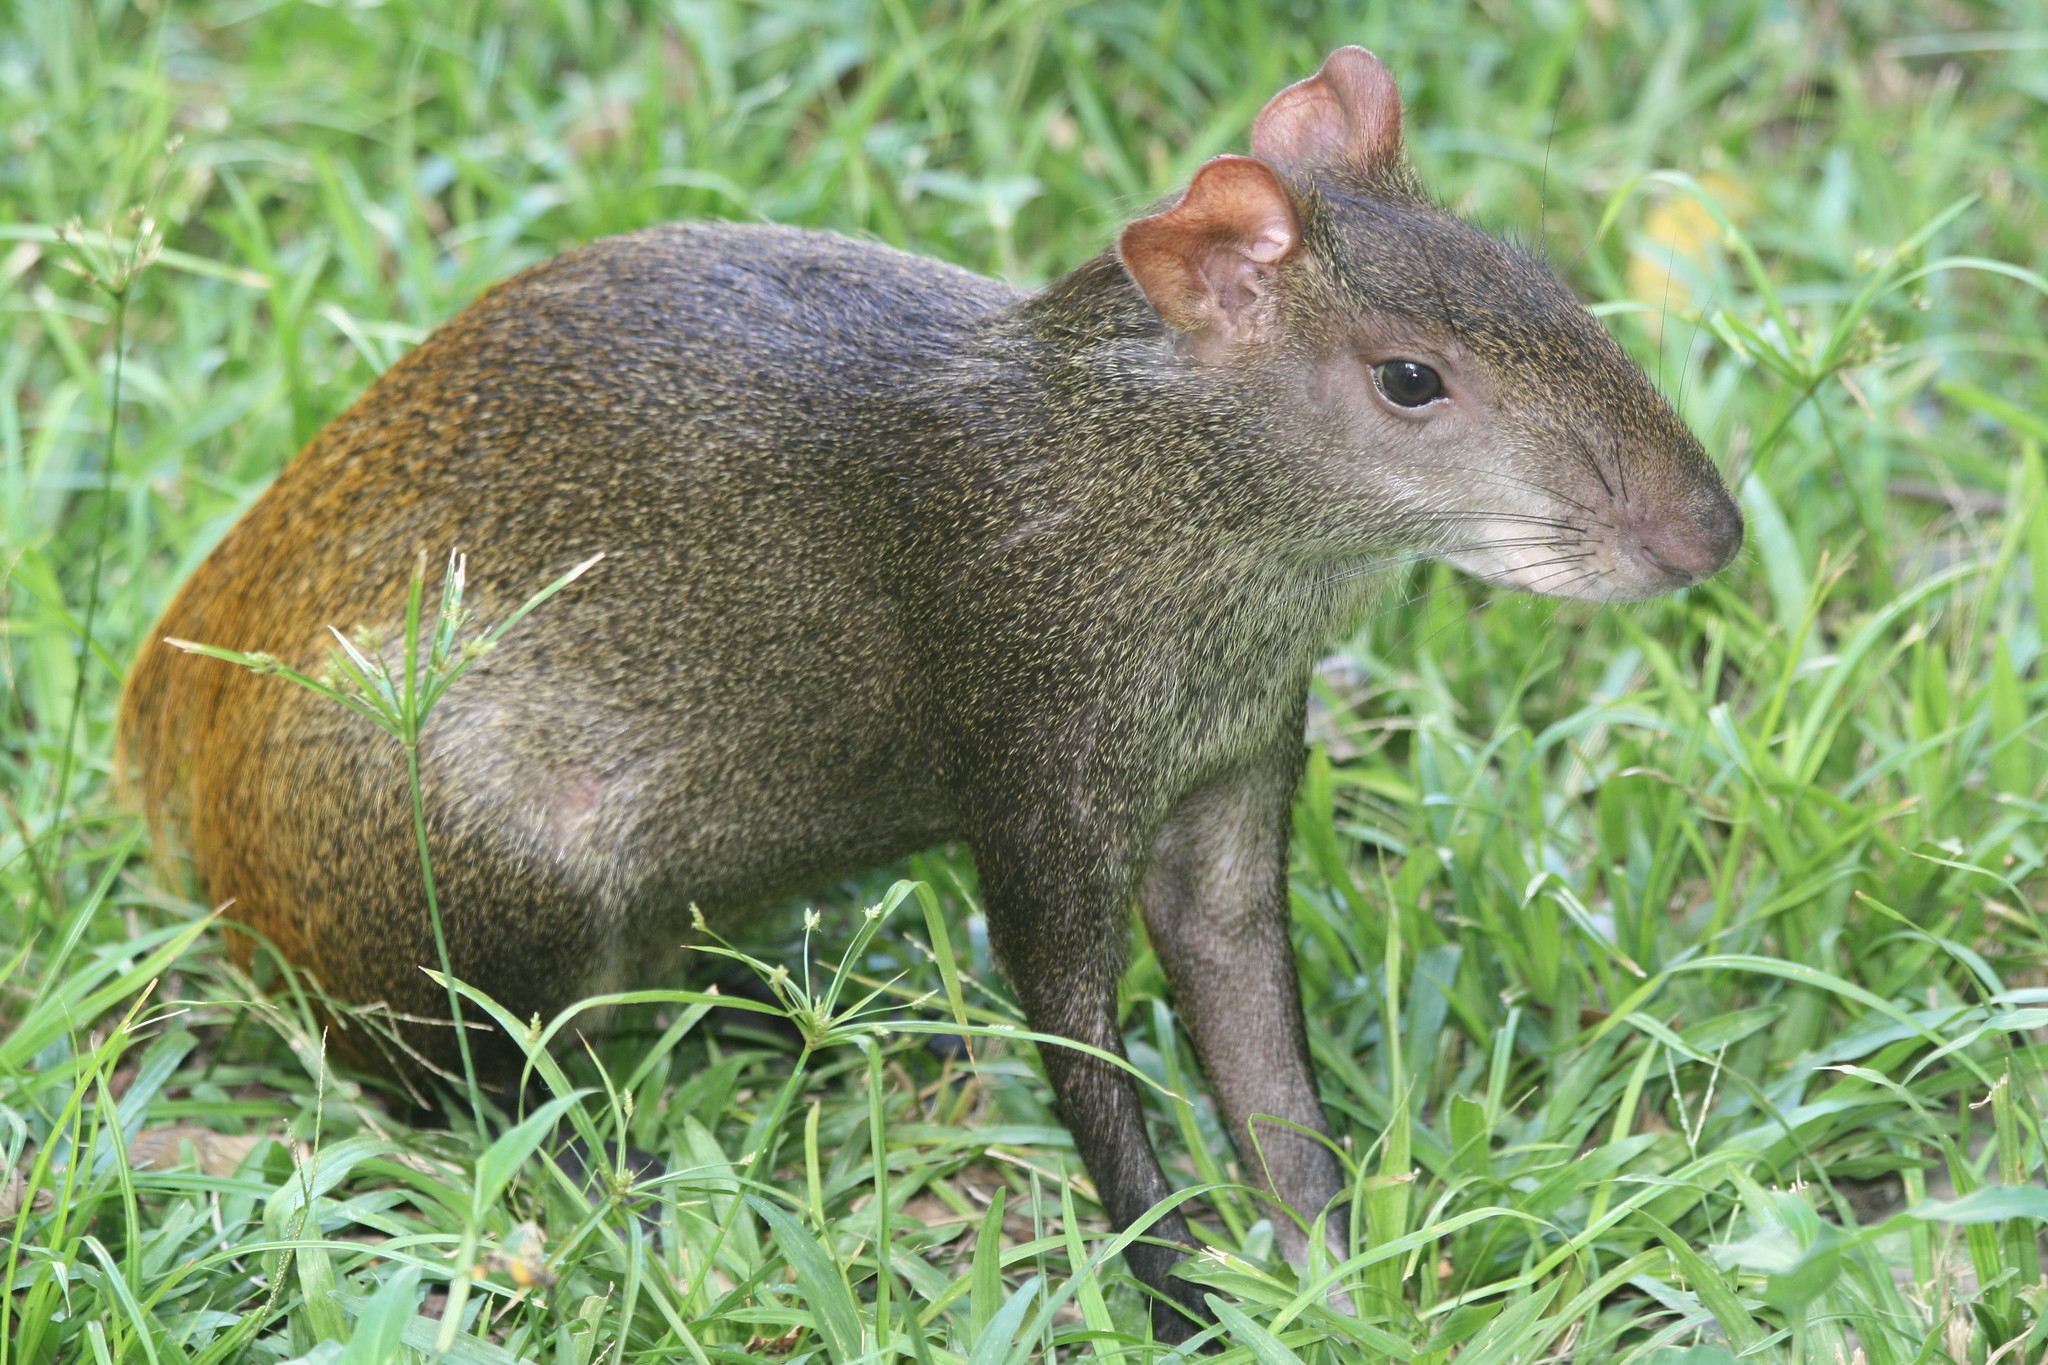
1139,749,1346,1265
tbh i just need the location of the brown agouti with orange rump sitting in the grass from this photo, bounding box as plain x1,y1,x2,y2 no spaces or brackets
121,47,1741,1338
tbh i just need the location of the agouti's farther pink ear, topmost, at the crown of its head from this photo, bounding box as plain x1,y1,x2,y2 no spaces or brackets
1251,47,1401,178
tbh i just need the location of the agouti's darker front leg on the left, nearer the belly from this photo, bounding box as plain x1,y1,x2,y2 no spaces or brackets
975,834,1210,1342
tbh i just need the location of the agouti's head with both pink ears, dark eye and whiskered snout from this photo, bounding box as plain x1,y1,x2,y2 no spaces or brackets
1118,47,1743,602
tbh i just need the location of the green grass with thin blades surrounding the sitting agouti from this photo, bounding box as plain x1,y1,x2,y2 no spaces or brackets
0,0,2048,1365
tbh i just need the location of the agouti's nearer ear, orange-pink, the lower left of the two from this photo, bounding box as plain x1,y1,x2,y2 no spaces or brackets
1116,156,1300,358
